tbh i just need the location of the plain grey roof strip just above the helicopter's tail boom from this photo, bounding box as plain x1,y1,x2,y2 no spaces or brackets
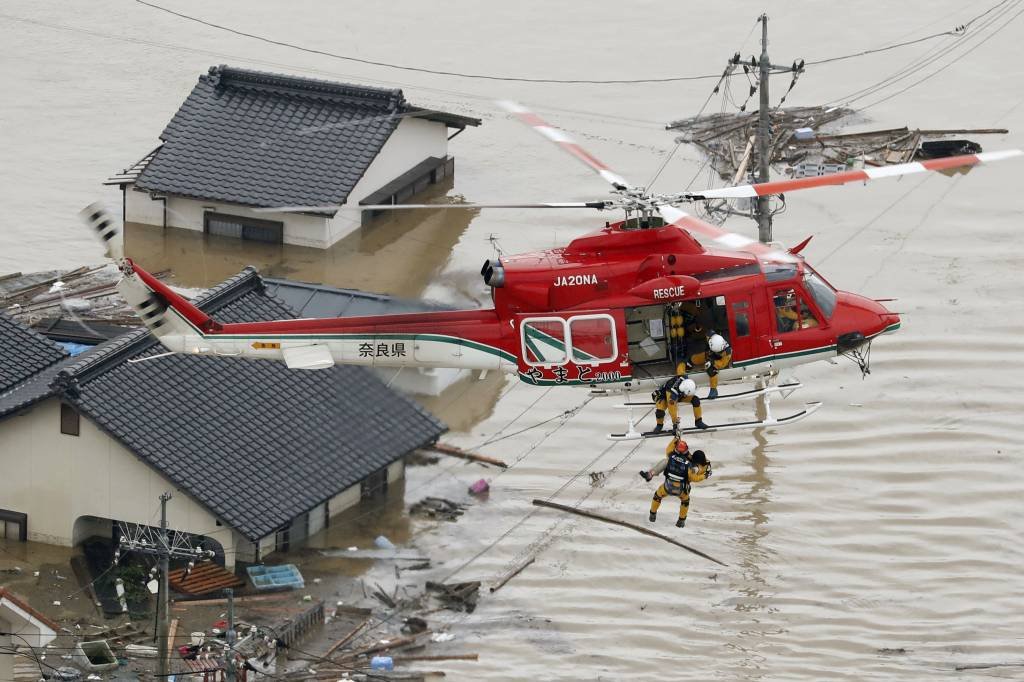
263,278,452,317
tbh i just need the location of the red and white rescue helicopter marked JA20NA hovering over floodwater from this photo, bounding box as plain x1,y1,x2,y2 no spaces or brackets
83,102,1022,438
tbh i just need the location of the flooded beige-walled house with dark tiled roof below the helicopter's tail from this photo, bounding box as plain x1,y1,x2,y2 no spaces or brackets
0,268,445,567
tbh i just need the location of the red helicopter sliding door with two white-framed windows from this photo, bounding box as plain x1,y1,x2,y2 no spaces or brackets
516,309,631,385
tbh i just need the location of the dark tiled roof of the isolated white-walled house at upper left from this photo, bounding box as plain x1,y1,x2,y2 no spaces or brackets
136,66,479,212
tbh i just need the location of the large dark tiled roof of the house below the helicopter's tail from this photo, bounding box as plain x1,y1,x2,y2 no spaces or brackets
7,268,445,540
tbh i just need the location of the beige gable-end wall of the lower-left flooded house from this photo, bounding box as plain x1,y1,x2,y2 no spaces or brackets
0,398,236,566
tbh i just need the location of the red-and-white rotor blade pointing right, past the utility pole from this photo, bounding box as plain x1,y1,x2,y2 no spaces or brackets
687,150,1024,200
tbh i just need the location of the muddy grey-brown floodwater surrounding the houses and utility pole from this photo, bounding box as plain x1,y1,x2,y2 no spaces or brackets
0,0,1024,681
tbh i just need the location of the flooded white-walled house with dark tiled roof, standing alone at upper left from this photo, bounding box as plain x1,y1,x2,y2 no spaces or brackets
104,66,480,248
